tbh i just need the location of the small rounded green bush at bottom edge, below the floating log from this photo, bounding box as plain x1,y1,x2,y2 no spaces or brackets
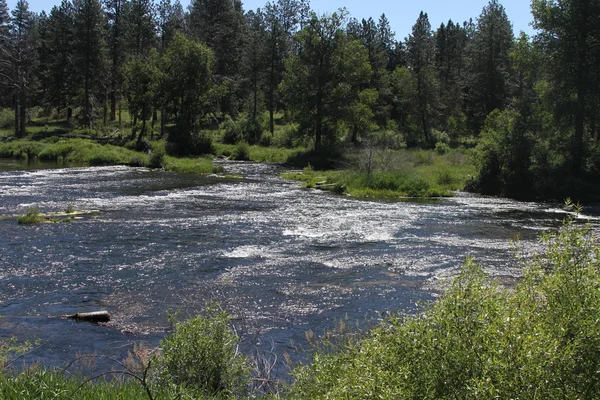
157,304,249,396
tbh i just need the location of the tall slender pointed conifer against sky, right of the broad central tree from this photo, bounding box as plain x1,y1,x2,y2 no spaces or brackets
406,11,437,146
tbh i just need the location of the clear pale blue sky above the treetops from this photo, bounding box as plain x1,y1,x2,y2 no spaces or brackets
8,0,534,40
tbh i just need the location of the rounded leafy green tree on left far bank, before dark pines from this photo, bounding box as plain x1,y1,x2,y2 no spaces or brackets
162,33,213,152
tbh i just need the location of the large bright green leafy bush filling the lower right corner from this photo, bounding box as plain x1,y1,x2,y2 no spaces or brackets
290,211,600,399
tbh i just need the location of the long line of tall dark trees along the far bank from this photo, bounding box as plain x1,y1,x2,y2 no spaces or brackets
0,0,600,197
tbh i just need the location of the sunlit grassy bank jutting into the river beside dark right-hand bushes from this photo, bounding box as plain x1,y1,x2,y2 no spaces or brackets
282,149,475,199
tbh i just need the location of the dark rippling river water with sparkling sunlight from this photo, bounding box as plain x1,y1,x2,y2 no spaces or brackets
0,163,598,372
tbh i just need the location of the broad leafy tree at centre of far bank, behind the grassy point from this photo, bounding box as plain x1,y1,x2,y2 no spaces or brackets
281,10,372,151
